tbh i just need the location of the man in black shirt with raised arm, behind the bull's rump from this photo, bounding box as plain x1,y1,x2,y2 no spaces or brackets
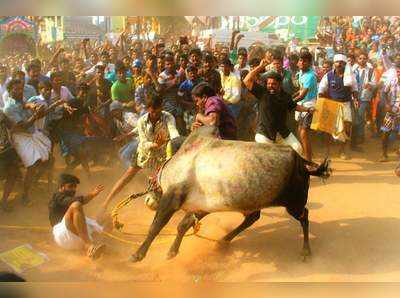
243,59,314,155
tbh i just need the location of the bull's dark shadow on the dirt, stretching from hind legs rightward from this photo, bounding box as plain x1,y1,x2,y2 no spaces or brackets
202,216,400,281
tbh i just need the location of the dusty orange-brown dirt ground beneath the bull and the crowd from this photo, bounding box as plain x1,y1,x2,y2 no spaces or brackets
0,140,400,282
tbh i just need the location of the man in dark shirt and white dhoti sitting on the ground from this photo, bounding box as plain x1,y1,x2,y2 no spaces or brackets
49,174,105,259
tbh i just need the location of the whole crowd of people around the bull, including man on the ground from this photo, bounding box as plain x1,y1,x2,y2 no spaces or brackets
0,17,400,255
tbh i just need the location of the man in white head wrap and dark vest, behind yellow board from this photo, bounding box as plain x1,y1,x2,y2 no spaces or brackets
318,54,359,159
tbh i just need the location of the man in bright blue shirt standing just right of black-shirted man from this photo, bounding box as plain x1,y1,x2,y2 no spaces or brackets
294,51,318,161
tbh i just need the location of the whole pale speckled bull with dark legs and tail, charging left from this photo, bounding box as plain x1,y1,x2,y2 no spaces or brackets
130,127,330,262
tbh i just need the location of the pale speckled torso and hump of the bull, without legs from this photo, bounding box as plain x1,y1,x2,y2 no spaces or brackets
160,127,298,213
